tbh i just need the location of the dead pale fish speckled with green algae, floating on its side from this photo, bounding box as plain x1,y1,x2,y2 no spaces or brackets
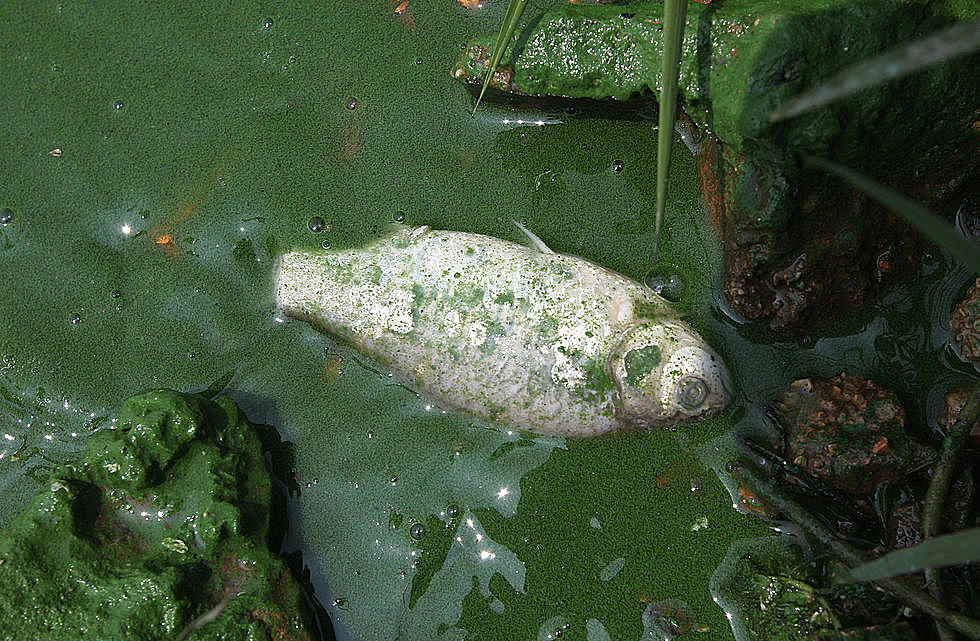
276,222,730,436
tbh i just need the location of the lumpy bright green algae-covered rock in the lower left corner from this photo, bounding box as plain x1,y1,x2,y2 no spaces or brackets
0,390,310,641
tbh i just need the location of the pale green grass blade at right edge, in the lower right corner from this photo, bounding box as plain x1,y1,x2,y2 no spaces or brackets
841,528,980,583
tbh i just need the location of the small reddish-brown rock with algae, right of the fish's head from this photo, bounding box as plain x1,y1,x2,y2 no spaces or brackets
776,374,932,496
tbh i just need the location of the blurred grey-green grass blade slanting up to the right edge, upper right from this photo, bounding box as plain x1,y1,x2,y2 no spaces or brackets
769,20,980,122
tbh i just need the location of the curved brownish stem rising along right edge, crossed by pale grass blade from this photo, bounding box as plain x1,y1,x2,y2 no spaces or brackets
922,389,980,641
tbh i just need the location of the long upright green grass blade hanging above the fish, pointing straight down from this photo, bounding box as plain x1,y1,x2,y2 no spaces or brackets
652,0,687,269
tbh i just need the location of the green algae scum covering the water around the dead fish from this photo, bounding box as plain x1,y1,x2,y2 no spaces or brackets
0,0,763,641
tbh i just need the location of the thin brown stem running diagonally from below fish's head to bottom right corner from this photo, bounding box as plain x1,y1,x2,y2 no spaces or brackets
733,466,980,641
